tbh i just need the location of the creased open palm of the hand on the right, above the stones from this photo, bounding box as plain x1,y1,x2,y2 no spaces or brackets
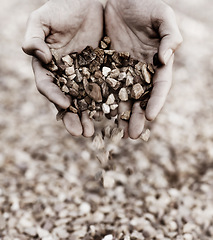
105,1,159,62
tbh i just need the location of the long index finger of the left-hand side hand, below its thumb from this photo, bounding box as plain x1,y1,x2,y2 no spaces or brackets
32,58,70,109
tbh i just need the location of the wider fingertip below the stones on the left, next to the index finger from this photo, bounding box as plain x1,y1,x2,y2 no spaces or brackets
63,112,83,137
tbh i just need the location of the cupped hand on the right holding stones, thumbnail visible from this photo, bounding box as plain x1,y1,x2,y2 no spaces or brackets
105,0,182,139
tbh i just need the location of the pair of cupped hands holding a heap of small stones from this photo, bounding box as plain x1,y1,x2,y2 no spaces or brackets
23,0,182,139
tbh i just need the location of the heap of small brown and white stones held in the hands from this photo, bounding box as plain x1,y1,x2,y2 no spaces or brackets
45,36,155,120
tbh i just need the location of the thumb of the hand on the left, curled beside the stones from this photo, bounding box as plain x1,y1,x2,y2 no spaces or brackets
22,10,52,64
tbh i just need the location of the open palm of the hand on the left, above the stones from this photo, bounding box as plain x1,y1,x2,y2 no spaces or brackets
40,0,103,55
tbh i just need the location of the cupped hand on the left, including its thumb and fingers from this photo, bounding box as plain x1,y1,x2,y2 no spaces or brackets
23,0,103,137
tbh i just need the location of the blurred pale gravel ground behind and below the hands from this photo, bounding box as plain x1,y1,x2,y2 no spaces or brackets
0,0,213,240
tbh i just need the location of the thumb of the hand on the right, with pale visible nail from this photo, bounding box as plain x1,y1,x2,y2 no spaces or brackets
158,5,183,64
